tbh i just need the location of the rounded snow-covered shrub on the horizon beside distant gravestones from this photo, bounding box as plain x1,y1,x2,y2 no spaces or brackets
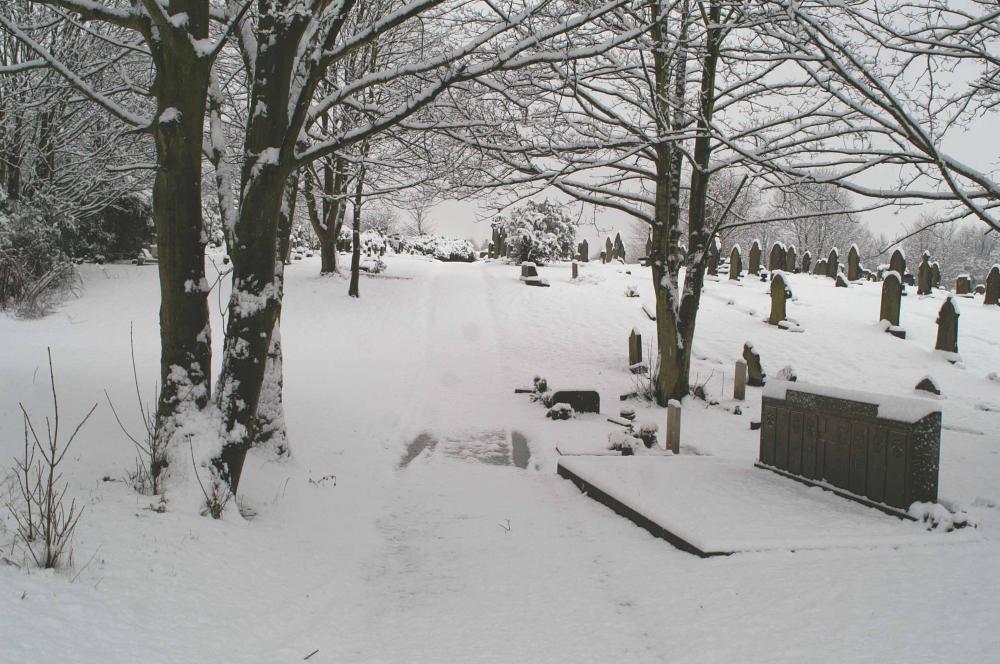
493,201,576,265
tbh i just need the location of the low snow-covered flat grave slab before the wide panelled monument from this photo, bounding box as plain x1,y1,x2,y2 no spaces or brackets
558,455,980,557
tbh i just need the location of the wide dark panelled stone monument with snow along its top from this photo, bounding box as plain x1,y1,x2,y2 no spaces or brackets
759,382,941,513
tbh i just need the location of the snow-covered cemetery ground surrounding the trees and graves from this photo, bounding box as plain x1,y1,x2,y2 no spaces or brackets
0,256,1000,663
